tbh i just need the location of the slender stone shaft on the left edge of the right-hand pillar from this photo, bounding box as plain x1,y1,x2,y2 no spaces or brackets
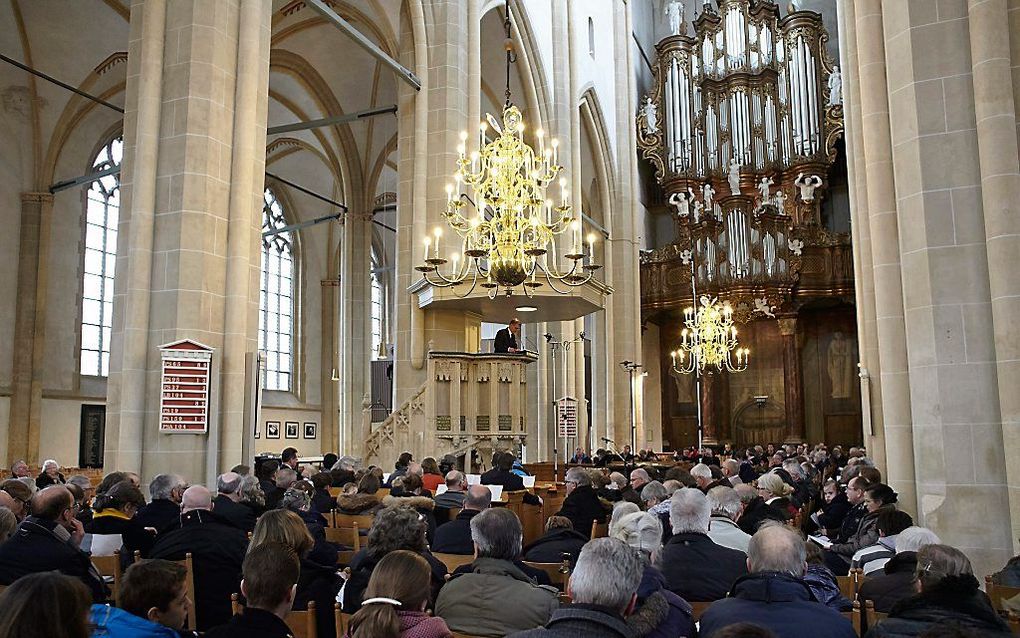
853,0,917,509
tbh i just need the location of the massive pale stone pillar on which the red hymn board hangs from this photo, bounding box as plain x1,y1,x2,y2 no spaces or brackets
105,0,271,482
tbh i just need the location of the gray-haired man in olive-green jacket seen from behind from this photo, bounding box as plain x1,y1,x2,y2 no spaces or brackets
436,507,558,636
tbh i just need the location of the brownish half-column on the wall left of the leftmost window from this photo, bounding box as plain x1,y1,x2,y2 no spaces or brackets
4,193,54,467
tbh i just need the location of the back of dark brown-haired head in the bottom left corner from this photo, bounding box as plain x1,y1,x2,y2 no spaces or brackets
0,572,92,638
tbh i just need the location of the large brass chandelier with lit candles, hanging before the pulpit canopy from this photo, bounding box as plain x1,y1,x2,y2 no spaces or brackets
415,2,602,298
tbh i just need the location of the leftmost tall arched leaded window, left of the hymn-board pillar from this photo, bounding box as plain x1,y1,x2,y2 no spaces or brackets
79,137,123,377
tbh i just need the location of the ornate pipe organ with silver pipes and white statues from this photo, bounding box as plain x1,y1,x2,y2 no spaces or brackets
638,0,843,318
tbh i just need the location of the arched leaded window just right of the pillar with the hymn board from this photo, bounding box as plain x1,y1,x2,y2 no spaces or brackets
258,188,295,391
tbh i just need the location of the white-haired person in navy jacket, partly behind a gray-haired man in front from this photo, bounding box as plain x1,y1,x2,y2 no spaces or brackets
611,511,697,638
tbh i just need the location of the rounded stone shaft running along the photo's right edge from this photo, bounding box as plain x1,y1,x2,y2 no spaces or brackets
968,0,1020,553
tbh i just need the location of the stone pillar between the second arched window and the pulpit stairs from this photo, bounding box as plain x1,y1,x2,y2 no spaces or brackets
340,211,373,450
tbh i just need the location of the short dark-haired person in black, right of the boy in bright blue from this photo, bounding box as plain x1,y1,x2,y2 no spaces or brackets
205,542,301,638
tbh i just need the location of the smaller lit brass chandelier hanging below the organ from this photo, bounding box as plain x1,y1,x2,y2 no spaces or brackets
670,295,751,376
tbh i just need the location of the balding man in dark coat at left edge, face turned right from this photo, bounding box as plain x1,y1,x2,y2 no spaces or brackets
0,485,107,602
